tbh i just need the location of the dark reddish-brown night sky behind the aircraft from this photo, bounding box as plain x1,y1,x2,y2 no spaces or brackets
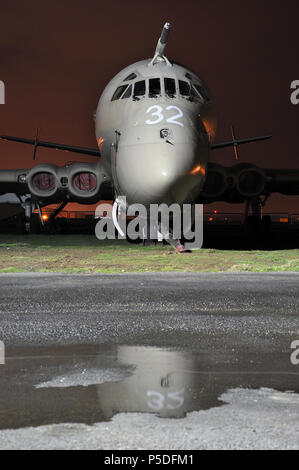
0,0,299,212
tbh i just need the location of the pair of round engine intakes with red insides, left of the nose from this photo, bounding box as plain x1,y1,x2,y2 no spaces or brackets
26,163,107,203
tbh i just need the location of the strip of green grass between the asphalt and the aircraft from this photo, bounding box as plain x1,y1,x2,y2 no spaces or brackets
0,235,299,273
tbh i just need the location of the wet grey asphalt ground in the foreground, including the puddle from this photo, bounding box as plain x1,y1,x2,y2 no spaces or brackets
0,273,299,449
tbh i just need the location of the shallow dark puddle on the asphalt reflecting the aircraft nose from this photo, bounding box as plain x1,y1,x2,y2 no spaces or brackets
0,345,299,429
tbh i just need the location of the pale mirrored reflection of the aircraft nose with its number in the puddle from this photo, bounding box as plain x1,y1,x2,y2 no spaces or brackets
98,346,223,418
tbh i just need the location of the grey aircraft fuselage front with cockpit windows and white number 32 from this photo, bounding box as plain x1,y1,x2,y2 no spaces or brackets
95,58,216,205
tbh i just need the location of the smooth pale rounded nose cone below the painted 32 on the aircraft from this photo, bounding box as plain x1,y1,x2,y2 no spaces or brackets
115,122,209,205
